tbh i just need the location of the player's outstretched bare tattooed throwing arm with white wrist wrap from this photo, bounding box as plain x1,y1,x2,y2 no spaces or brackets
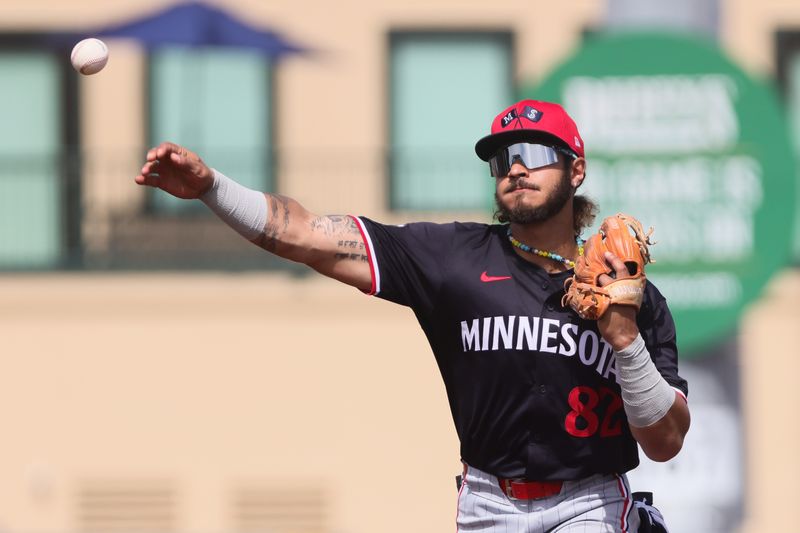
134,143,372,291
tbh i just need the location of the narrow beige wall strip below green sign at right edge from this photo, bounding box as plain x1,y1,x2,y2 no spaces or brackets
740,269,800,533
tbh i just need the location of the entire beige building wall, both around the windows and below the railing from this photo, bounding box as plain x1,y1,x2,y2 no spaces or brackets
0,0,800,533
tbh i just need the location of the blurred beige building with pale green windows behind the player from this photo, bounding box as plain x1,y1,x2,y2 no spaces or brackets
0,0,800,533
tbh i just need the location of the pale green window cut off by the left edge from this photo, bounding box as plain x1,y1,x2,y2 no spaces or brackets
0,49,65,269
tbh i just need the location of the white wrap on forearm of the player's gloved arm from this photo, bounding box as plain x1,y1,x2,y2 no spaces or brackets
615,335,675,428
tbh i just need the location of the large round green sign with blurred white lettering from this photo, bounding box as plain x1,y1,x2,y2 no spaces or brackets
521,33,795,357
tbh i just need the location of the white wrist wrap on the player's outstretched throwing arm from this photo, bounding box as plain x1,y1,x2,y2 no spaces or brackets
200,169,267,240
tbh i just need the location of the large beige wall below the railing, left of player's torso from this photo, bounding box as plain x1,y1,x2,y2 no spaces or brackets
0,274,460,533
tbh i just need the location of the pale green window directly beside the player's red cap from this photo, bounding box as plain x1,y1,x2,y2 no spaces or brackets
389,32,514,210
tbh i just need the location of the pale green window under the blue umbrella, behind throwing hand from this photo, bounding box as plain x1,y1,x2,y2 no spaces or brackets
150,47,273,213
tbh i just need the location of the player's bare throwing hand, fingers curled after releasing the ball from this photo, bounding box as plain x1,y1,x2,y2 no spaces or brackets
134,142,214,199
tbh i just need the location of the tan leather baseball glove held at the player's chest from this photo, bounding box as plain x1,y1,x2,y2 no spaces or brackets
561,213,655,320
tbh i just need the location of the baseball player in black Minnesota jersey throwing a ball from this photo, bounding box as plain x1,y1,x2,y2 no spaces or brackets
135,100,689,533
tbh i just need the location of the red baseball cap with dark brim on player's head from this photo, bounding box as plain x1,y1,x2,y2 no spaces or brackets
475,100,585,161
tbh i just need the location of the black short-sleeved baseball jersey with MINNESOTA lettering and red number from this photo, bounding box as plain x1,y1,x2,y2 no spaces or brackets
356,217,687,480
